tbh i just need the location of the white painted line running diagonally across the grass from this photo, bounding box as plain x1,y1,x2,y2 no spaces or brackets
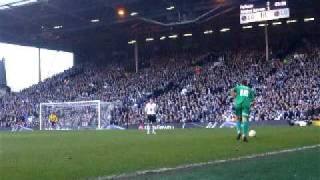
92,144,320,180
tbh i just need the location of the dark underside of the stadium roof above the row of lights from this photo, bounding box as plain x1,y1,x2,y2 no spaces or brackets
0,0,320,49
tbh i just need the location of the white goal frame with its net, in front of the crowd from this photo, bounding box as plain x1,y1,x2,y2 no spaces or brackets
39,100,121,130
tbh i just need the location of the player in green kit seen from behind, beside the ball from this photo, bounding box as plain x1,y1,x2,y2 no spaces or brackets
231,80,255,142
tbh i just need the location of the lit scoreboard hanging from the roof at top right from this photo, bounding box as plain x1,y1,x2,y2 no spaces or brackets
240,0,290,24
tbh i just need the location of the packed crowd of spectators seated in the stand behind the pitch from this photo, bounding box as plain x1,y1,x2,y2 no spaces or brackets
0,45,320,127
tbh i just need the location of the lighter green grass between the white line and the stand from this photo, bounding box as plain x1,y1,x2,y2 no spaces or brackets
0,127,320,180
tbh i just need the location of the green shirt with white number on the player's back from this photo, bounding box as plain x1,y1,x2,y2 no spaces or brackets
234,85,256,105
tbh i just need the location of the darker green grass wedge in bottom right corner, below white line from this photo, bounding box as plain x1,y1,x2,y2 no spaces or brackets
131,148,320,180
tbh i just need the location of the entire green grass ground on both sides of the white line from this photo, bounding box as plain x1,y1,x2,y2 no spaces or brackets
0,126,320,180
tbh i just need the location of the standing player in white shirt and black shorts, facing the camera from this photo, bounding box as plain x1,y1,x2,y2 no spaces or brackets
144,98,157,134
